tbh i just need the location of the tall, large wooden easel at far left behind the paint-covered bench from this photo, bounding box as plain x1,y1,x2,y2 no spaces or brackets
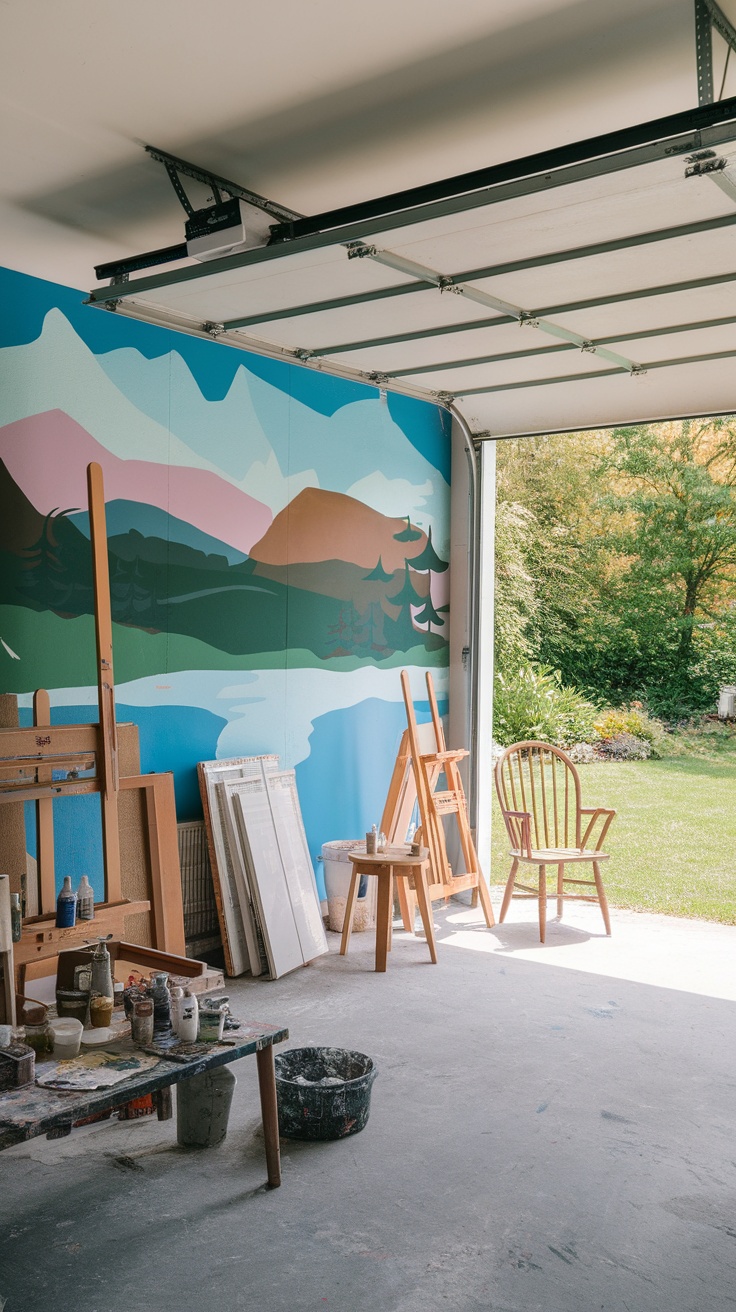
0,463,186,977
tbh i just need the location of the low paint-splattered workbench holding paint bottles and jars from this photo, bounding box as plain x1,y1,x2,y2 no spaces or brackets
0,1021,289,1189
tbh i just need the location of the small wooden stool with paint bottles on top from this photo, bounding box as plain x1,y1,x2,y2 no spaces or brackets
340,848,437,971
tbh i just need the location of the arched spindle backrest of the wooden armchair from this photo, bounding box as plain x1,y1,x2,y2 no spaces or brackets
496,741,581,850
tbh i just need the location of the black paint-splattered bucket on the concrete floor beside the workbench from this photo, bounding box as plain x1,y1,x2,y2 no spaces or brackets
276,1048,378,1139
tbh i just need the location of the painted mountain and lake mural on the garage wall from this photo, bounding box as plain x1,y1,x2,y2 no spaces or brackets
0,270,450,902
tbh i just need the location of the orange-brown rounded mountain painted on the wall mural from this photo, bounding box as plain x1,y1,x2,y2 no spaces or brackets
249,488,426,573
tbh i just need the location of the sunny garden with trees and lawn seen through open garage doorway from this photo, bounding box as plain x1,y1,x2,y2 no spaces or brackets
492,416,736,925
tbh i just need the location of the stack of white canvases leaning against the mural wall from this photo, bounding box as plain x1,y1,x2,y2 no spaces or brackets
198,756,327,979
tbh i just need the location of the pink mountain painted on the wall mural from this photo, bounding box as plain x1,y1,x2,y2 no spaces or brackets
0,409,273,554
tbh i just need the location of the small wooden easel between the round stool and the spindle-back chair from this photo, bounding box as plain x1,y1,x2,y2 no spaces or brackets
382,670,496,933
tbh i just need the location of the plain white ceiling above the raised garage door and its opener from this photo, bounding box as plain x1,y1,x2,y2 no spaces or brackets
0,0,736,287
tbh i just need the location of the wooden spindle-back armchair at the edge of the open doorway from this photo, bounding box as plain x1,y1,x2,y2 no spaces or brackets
496,741,615,942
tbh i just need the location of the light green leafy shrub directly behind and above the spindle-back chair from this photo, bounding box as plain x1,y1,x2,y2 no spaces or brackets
493,665,600,747
